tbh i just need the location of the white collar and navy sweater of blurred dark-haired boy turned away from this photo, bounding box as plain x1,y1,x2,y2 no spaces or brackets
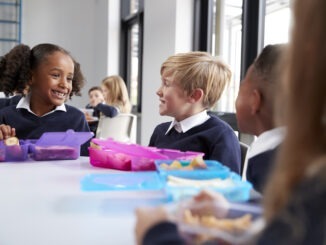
242,127,285,193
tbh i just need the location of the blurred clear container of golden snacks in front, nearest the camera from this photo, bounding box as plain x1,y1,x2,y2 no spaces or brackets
170,200,265,245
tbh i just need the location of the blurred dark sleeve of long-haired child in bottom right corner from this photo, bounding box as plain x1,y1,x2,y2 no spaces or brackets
256,162,326,245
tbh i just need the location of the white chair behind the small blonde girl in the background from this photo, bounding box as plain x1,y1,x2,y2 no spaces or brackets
96,113,137,143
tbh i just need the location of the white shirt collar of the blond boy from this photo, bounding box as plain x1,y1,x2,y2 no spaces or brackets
165,110,210,134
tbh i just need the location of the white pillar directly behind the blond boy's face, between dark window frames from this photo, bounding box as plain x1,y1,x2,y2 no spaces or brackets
140,0,193,145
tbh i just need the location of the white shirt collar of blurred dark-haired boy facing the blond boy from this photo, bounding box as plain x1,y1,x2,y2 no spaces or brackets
242,127,286,180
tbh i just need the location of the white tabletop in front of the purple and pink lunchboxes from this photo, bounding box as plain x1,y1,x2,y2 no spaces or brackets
0,157,167,245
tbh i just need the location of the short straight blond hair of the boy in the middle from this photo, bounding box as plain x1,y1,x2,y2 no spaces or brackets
161,51,232,108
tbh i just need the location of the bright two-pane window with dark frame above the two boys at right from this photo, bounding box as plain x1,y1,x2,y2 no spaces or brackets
206,0,290,112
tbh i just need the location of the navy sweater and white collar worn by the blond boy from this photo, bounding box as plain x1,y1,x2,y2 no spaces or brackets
149,110,241,173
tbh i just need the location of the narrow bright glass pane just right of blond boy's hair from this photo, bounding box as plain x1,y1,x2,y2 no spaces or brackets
212,0,242,112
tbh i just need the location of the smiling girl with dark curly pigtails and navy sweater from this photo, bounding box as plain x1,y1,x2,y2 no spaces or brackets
0,43,89,155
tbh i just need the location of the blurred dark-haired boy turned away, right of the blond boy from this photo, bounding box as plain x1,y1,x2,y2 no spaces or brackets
235,44,285,192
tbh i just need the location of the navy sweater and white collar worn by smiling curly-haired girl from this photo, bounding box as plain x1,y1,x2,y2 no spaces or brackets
0,96,90,156
